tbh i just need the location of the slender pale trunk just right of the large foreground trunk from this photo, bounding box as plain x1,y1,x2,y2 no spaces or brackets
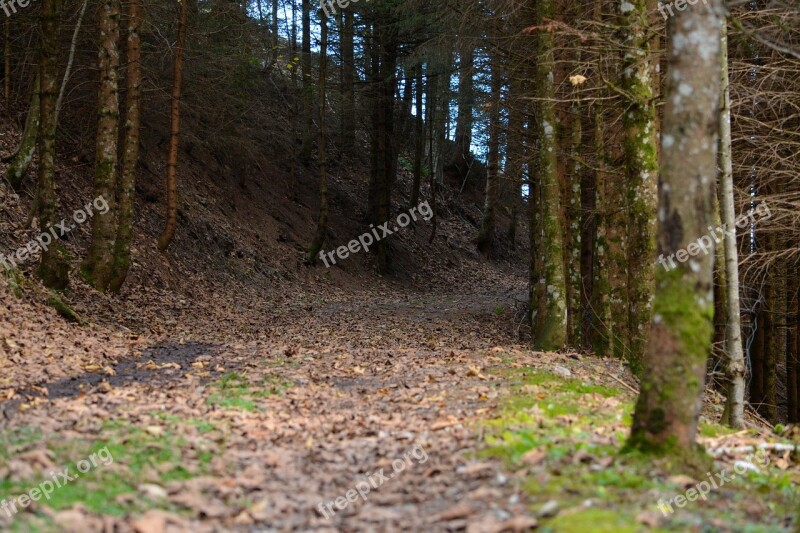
719,20,745,428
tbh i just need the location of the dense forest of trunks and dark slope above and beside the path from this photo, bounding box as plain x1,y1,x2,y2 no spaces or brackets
0,0,800,530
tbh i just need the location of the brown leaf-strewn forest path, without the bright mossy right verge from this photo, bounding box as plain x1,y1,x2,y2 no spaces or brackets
0,293,568,533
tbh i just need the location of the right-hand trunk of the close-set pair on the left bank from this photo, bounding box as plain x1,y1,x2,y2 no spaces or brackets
109,0,142,293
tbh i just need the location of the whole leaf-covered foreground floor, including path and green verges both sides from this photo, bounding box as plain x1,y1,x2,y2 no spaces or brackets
0,291,799,533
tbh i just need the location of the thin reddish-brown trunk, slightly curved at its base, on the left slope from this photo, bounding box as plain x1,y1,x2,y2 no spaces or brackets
158,0,189,252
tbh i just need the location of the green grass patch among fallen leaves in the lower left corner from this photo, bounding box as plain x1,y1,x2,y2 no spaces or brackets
0,413,224,531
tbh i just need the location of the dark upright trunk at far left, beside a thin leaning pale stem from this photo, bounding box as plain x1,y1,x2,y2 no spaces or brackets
37,0,69,289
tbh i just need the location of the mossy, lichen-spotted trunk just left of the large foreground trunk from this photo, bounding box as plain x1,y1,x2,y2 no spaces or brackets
619,0,658,373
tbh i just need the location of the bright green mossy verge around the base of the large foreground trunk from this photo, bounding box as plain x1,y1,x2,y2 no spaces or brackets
479,368,800,533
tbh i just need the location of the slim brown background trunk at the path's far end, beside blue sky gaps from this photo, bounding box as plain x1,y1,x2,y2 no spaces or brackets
476,64,503,257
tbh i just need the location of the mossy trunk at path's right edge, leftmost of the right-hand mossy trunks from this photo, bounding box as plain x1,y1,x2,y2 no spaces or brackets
531,0,567,350
